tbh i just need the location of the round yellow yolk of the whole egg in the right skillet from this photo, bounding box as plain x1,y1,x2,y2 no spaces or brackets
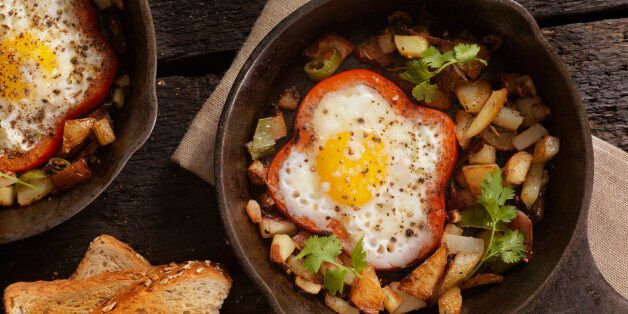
316,132,388,206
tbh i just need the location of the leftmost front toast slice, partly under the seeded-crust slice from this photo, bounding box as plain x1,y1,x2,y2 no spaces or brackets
4,271,146,314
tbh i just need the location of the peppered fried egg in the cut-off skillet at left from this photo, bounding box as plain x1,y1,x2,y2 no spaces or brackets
0,0,115,155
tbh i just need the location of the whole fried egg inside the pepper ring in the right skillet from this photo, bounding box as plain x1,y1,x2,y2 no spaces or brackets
271,72,455,269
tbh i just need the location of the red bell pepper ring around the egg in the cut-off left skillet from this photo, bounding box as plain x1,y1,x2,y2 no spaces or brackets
0,0,118,172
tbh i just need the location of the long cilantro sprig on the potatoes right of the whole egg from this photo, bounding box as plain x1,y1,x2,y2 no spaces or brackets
463,169,526,278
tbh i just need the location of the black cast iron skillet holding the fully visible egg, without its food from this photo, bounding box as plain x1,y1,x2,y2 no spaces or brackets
215,0,626,313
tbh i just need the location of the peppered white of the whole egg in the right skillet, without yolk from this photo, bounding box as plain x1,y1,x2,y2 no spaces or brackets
276,84,442,269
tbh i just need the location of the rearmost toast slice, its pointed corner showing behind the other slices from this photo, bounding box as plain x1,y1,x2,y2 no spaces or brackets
70,234,151,279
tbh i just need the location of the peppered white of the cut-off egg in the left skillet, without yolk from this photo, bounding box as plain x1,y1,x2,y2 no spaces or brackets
0,0,104,155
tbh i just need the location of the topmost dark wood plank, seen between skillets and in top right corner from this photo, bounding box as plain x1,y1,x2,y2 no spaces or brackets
149,0,628,63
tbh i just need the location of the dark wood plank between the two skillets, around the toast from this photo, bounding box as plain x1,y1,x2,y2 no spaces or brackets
0,75,268,313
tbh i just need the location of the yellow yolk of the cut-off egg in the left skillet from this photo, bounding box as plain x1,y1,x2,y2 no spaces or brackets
0,34,57,100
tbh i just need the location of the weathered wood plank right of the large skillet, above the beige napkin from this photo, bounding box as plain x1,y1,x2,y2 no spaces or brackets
544,18,628,151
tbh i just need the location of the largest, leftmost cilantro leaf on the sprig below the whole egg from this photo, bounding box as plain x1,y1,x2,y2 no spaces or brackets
297,236,342,273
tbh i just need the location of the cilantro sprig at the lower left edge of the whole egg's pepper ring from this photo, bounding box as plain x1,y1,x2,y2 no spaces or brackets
297,235,368,294
